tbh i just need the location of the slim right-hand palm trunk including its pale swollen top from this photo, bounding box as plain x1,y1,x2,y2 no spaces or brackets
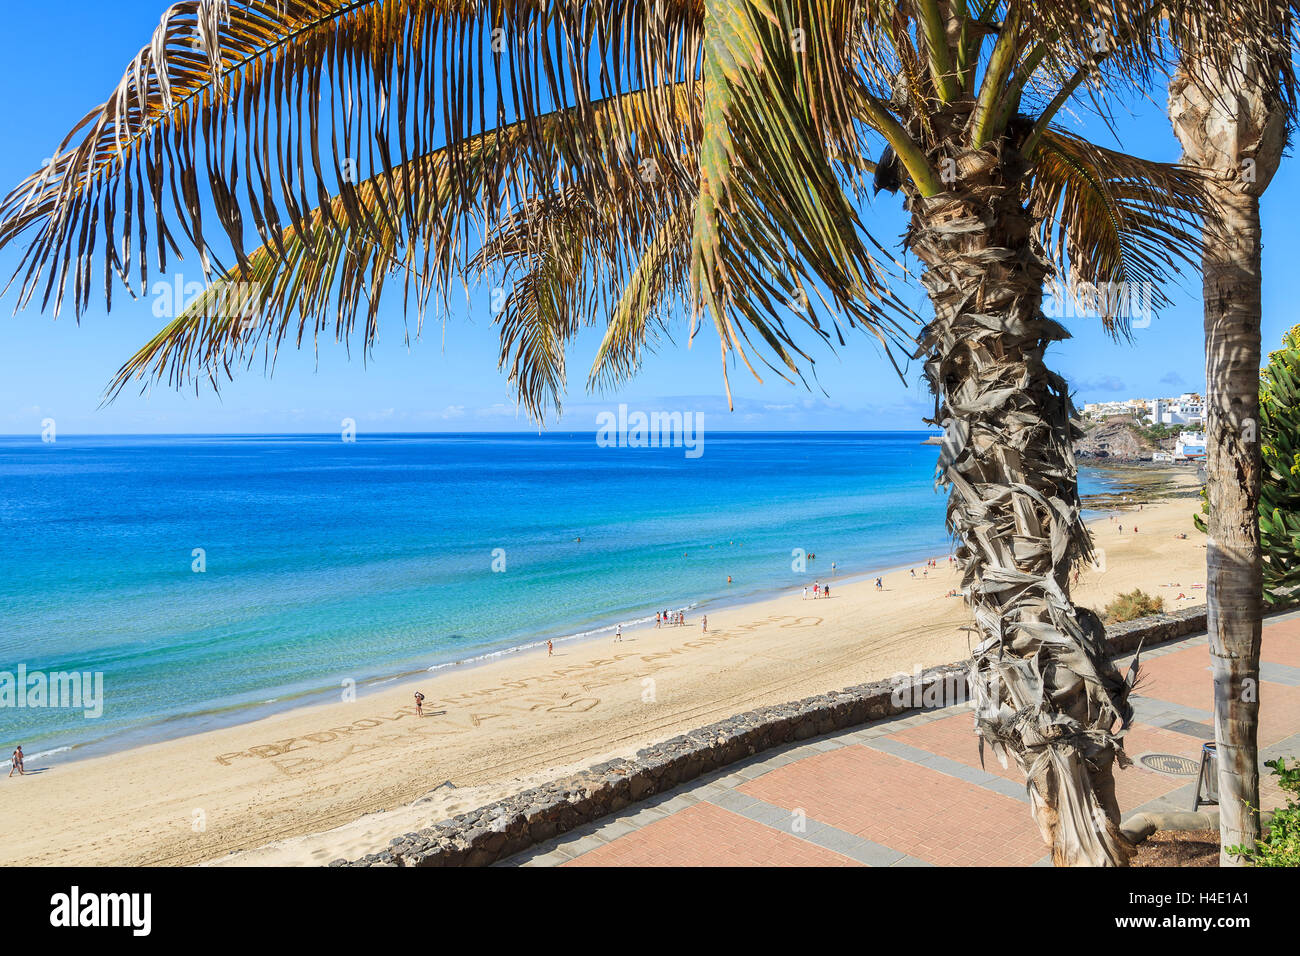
1169,57,1286,865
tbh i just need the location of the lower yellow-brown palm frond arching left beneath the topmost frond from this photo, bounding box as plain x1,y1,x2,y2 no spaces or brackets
108,85,707,398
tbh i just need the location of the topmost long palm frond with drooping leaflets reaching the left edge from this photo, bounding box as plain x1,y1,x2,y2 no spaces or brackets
0,0,701,321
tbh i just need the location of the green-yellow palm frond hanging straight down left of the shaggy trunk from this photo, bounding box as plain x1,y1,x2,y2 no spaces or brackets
692,0,913,395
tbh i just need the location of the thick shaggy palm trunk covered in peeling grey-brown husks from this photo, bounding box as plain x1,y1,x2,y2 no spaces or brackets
907,144,1132,866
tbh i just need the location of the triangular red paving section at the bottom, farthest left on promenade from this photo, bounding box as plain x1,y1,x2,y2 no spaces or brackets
563,803,861,866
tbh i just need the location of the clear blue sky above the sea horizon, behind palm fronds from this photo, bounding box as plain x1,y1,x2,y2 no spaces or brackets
0,0,1300,434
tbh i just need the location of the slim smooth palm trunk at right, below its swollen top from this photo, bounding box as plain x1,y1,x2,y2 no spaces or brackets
1203,183,1264,866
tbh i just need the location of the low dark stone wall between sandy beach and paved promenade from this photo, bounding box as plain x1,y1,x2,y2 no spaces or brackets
330,606,1205,866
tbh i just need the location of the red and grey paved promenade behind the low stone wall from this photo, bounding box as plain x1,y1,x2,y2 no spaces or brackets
502,614,1300,866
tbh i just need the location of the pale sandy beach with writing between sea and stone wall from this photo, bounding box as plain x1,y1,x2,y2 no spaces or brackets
0,473,1205,865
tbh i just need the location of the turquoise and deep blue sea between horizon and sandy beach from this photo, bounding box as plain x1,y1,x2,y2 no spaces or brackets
0,432,1118,756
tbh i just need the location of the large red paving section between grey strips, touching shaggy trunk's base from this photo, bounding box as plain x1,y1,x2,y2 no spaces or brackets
740,747,1048,866
